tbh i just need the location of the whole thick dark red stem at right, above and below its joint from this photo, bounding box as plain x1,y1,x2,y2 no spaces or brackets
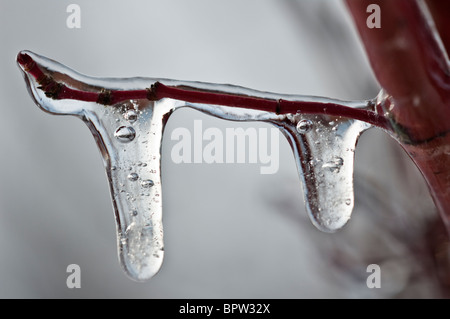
347,0,450,234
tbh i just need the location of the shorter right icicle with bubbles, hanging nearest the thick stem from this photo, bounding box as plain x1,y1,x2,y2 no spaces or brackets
275,114,370,232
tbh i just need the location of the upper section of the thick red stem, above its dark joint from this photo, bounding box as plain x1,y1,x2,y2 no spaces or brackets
347,0,450,141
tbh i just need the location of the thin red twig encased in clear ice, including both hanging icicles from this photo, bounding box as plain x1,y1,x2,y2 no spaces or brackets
17,52,380,281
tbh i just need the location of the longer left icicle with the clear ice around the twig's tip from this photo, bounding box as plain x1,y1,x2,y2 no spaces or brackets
16,52,181,281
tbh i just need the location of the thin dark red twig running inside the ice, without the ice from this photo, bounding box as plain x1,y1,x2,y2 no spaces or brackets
17,53,390,130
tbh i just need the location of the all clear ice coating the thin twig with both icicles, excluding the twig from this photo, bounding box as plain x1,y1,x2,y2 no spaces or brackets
19,51,370,281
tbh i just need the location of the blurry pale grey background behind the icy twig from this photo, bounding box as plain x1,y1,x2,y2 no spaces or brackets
0,0,442,298
